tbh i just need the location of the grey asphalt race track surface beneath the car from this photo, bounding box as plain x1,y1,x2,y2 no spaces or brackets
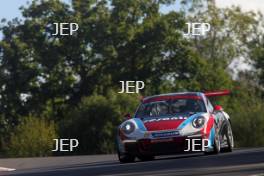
0,148,264,176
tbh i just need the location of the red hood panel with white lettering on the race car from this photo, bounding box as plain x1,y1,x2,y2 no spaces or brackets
142,114,191,131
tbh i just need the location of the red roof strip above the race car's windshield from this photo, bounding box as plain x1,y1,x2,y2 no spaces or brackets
142,92,203,103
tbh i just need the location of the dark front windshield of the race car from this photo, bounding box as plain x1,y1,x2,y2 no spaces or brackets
136,99,206,117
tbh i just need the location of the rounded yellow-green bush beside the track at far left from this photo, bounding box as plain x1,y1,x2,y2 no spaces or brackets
7,116,57,157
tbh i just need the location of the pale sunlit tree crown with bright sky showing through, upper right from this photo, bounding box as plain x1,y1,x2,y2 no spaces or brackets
187,1,261,69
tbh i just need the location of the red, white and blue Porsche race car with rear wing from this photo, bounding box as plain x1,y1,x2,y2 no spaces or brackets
117,90,234,163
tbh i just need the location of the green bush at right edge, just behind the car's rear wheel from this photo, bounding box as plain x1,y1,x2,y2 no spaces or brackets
225,83,264,147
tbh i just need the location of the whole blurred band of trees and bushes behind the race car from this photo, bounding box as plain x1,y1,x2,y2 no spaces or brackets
0,0,264,157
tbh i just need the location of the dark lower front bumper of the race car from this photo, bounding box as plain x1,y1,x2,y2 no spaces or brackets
120,136,203,155
